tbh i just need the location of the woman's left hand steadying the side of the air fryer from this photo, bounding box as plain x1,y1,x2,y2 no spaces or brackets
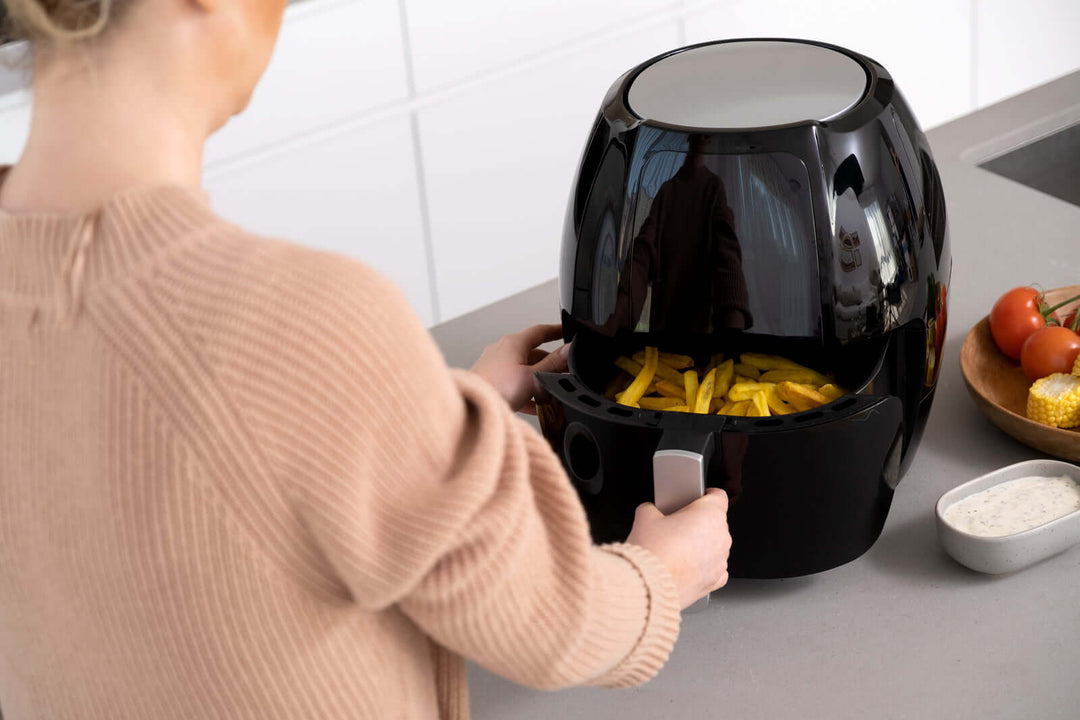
472,325,570,415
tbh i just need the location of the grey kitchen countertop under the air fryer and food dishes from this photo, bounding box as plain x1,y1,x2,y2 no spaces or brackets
433,72,1080,720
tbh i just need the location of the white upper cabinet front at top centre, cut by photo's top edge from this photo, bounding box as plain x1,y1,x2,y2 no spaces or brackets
402,0,681,92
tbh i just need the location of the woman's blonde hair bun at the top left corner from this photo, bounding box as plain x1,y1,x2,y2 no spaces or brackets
3,0,125,43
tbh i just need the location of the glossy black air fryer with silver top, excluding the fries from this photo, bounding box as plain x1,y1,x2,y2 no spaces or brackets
540,39,951,578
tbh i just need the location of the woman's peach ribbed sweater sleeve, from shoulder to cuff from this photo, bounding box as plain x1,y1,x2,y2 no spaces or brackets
157,236,679,688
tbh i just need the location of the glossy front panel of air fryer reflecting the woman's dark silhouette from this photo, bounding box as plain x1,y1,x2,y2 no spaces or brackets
597,128,820,337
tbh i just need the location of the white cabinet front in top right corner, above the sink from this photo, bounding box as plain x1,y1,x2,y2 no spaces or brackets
975,0,1080,106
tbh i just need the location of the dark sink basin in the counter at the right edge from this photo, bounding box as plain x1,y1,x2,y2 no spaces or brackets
980,123,1080,206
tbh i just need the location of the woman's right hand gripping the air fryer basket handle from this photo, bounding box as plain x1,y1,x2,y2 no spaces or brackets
626,488,731,609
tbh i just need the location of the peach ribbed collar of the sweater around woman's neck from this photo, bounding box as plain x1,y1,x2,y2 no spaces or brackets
0,167,215,298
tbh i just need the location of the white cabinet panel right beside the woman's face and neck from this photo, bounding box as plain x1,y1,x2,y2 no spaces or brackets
206,0,408,164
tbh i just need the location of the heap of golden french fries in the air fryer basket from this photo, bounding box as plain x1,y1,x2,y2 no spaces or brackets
605,347,847,418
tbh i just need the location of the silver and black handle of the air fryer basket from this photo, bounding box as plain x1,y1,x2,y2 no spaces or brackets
652,432,716,612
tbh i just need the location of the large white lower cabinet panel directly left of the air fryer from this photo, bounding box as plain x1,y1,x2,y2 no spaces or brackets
419,21,678,320
